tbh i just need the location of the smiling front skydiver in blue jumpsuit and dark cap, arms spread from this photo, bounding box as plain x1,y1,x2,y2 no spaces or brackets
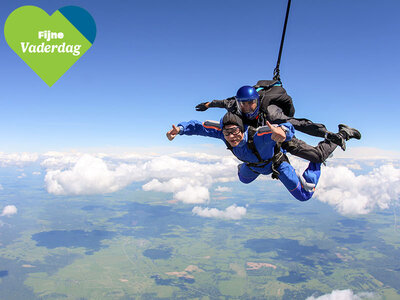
167,112,321,201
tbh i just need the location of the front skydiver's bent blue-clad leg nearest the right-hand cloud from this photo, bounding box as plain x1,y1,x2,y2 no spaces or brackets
278,162,321,201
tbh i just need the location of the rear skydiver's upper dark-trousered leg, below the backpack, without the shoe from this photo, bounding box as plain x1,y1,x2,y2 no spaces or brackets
267,104,328,138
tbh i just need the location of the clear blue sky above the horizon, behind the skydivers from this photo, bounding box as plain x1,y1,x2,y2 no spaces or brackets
0,0,400,152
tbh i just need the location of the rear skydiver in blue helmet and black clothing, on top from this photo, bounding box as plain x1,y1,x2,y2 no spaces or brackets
196,80,361,163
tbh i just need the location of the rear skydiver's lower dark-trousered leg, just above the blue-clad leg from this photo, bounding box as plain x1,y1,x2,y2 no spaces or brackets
282,137,337,163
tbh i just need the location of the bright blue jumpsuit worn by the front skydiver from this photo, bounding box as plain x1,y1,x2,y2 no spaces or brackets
178,120,321,201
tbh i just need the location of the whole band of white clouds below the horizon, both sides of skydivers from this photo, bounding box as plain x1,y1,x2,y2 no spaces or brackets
0,152,400,215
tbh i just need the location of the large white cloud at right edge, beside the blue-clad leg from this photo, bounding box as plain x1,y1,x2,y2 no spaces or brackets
315,164,400,214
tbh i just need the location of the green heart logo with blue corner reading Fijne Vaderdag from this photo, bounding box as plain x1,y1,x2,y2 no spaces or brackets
4,6,96,86
